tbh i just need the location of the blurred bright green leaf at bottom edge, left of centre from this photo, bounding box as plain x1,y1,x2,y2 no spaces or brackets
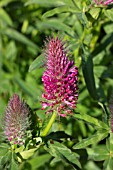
27,154,51,170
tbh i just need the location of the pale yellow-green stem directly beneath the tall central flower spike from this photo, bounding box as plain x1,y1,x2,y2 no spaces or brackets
41,111,57,136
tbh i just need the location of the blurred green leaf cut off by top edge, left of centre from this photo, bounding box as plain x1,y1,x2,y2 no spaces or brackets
25,0,65,7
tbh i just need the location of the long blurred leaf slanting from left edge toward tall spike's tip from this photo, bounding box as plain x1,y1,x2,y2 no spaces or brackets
0,28,38,49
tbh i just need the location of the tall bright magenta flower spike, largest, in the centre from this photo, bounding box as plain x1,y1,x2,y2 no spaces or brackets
42,37,78,117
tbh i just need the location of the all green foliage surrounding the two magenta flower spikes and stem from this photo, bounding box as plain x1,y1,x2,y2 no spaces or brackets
0,0,113,170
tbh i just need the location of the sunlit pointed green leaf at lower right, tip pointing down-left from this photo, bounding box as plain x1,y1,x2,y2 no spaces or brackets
73,131,108,149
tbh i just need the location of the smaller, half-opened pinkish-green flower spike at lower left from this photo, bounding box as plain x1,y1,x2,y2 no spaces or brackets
4,94,30,145
